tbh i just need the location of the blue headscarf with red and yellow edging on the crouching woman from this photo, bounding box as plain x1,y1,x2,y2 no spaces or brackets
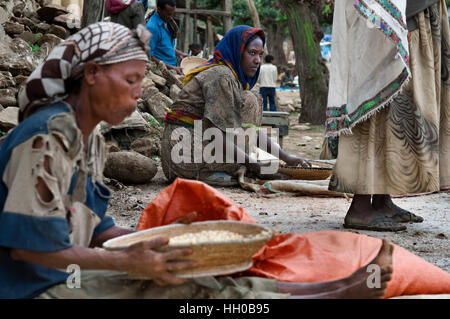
183,25,266,90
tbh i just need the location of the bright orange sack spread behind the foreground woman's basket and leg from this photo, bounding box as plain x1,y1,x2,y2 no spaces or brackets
137,178,450,298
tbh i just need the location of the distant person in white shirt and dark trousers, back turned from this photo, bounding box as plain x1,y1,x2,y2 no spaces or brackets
258,55,278,112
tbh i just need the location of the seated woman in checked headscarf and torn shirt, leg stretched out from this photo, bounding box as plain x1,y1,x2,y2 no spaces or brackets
0,22,393,299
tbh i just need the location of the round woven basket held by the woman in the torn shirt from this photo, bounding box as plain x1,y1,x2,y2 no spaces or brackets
103,220,273,279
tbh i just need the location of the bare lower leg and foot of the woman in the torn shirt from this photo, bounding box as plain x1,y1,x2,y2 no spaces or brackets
279,240,394,299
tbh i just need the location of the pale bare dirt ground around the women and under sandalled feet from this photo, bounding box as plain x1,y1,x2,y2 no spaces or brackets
108,93,450,272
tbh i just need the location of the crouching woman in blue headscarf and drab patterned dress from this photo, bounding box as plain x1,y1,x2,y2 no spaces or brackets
161,25,308,185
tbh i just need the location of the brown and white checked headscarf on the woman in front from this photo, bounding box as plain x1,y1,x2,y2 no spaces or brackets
19,22,150,122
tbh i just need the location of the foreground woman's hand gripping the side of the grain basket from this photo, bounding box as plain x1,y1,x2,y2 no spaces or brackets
123,237,196,286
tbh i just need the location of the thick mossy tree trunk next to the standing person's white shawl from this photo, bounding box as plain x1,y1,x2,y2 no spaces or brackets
280,0,329,124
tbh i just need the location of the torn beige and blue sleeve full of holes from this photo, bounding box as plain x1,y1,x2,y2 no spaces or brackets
0,134,74,252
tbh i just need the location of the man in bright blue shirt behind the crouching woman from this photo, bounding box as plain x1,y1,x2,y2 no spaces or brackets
147,0,188,74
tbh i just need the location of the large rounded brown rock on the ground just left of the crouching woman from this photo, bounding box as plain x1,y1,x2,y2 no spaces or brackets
103,152,157,184
